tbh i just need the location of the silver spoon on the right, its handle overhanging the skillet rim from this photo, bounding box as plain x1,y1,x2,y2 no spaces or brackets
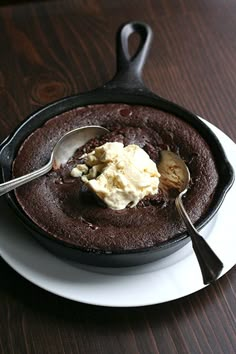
158,150,223,284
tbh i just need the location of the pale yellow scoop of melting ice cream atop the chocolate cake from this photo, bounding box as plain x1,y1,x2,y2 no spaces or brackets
71,142,160,210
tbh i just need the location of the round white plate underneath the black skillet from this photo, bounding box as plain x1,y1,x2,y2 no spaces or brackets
0,122,236,307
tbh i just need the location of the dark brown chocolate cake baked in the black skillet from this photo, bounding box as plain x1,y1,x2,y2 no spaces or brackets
13,104,218,251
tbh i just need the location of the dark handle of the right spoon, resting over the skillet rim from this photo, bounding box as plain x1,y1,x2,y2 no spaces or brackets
175,193,223,284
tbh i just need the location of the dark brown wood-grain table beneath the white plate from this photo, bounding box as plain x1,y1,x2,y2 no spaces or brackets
0,0,236,354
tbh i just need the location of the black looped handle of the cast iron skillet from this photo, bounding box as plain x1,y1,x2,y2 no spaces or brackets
105,22,152,90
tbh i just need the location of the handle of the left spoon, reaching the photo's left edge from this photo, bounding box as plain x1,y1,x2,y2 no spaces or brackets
0,162,52,196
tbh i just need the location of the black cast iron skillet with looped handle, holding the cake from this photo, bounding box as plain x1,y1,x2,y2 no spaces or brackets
0,22,234,267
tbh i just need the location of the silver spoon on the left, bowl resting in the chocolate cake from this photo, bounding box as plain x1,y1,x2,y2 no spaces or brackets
0,125,109,196
